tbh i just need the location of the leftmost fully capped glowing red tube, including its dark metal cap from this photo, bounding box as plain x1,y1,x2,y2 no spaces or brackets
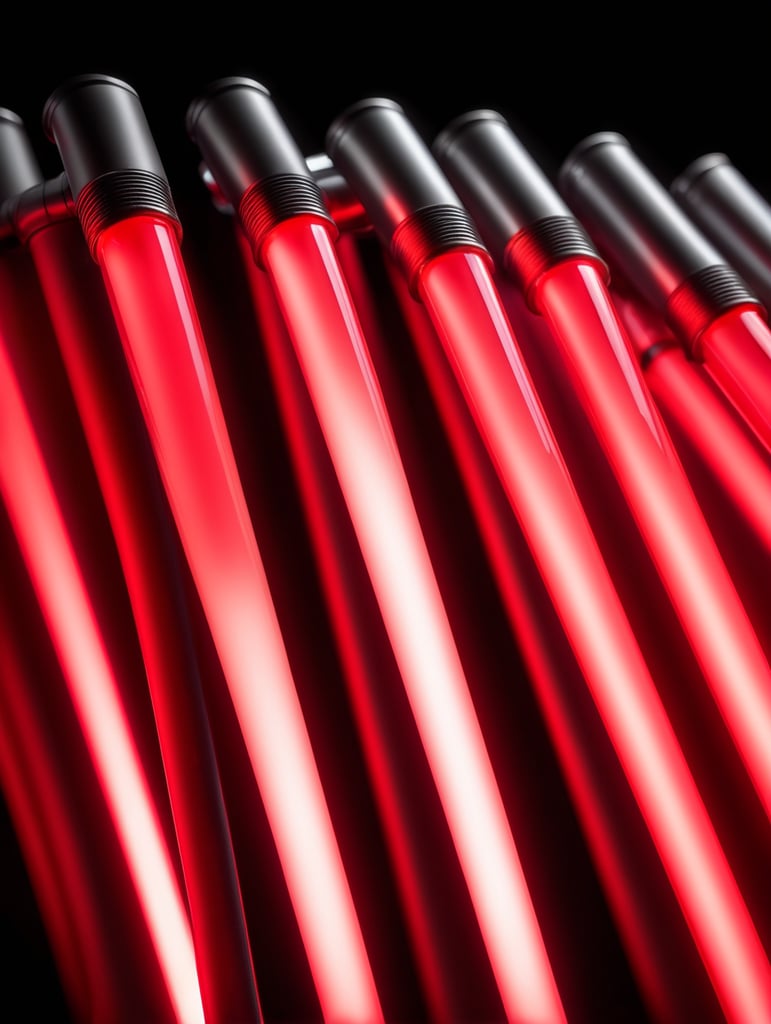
45,76,382,1024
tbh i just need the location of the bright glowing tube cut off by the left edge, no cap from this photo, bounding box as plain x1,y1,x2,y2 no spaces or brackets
0,278,203,1024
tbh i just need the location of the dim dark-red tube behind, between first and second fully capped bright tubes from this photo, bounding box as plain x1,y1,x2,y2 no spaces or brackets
231,230,481,1020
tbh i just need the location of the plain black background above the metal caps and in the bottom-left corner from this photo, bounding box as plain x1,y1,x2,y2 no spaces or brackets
0,16,771,1024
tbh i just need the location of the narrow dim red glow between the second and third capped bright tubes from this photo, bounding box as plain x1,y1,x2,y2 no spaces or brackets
388,261,704,1019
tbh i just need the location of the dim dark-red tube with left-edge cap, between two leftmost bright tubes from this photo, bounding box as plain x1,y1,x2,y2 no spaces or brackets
0,105,260,1024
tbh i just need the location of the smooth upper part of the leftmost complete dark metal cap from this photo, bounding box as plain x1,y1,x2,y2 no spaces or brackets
43,75,168,201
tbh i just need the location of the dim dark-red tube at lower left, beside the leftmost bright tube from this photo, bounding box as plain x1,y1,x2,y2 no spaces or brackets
0,528,192,1024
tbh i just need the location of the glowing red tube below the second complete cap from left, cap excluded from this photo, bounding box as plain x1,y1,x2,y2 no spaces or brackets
261,218,564,1022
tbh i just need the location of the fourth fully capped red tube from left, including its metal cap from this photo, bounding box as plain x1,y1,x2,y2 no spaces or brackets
435,111,771,817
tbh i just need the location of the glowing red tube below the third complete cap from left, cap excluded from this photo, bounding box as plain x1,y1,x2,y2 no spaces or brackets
420,252,771,1024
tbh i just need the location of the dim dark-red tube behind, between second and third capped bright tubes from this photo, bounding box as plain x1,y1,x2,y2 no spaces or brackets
388,260,729,1020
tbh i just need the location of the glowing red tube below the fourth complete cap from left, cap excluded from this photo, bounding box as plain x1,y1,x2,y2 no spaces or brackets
534,261,771,816
